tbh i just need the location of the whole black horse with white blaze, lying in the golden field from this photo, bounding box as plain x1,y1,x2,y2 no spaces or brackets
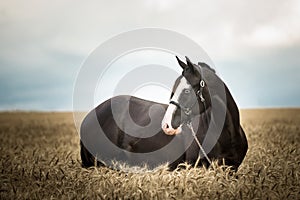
80,57,248,170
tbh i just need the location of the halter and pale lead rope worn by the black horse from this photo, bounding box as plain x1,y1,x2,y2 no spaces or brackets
170,77,212,167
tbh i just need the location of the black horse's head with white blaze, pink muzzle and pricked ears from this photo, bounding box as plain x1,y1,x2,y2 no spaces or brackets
162,56,211,135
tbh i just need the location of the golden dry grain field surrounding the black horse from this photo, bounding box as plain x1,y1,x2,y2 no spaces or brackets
0,109,300,199
